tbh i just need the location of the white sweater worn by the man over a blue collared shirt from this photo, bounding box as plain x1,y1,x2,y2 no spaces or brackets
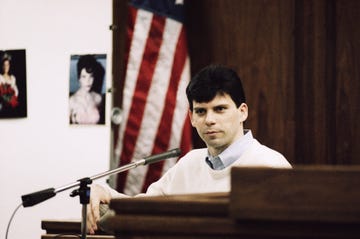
111,139,291,196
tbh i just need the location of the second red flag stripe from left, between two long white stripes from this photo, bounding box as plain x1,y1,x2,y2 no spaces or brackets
117,15,165,192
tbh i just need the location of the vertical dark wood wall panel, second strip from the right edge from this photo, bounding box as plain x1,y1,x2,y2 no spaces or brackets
294,0,335,164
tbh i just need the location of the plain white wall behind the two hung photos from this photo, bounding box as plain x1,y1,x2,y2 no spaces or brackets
0,0,112,239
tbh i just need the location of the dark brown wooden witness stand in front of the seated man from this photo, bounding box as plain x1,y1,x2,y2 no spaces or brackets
42,166,360,239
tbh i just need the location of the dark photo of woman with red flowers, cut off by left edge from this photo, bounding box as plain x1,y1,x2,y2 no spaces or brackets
0,50,27,118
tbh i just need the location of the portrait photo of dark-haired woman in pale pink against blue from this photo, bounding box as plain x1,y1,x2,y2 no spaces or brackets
69,54,106,124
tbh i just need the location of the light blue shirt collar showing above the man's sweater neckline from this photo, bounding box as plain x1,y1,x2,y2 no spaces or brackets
205,129,254,170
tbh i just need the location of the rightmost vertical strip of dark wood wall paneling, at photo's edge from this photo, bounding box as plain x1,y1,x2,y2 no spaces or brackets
329,0,360,164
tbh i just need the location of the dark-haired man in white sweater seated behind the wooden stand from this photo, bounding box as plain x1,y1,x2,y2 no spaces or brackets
88,65,291,233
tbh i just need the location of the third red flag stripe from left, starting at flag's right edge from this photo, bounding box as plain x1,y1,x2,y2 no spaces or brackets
142,27,187,192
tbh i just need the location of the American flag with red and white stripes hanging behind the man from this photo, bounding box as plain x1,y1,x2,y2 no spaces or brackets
115,0,192,195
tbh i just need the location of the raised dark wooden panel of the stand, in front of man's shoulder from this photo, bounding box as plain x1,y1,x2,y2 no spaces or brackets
229,165,360,222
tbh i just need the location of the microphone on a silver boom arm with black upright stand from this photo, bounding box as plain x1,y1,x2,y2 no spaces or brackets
21,148,181,239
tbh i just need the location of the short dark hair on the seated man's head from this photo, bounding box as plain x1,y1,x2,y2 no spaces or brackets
186,65,245,111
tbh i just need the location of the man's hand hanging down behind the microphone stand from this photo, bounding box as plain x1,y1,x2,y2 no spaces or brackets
86,184,111,234
